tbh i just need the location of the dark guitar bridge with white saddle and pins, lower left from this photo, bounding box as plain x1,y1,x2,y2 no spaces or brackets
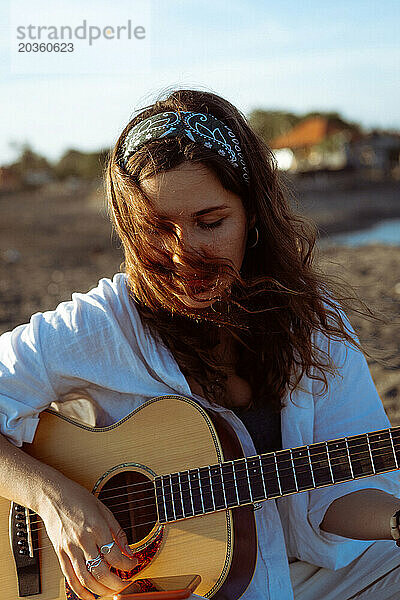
9,502,41,598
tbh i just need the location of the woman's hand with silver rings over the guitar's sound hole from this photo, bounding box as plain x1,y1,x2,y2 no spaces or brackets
38,476,137,600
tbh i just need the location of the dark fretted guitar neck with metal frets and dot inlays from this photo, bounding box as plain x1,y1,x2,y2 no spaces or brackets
155,427,400,523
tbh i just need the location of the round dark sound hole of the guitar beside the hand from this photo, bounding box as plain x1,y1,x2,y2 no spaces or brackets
98,471,158,544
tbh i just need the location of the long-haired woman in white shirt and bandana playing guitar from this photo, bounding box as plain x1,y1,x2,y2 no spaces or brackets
0,90,400,600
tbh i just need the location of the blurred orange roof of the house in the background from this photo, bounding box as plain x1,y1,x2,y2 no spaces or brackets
269,117,347,149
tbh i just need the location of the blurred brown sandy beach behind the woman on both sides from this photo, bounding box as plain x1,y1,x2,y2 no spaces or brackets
0,177,400,425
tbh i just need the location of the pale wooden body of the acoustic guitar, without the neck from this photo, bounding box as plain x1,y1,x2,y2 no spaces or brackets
0,396,257,600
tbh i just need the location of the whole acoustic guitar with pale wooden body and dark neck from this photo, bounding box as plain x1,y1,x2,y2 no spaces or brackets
0,395,400,600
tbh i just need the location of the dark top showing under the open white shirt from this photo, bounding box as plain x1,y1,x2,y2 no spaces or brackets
231,405,282,454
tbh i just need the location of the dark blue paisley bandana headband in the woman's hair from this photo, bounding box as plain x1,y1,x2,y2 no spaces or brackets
118,111,250,183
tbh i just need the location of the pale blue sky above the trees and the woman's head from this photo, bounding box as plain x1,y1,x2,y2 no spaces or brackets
0,0,400,164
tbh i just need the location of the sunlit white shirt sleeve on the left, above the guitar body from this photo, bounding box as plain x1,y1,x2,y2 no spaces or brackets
0,279,123,446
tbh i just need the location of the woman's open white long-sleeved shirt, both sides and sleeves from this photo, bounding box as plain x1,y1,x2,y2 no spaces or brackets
0,273,400,600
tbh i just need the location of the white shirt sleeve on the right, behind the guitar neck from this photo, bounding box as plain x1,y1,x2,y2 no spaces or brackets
276,314,400,569
